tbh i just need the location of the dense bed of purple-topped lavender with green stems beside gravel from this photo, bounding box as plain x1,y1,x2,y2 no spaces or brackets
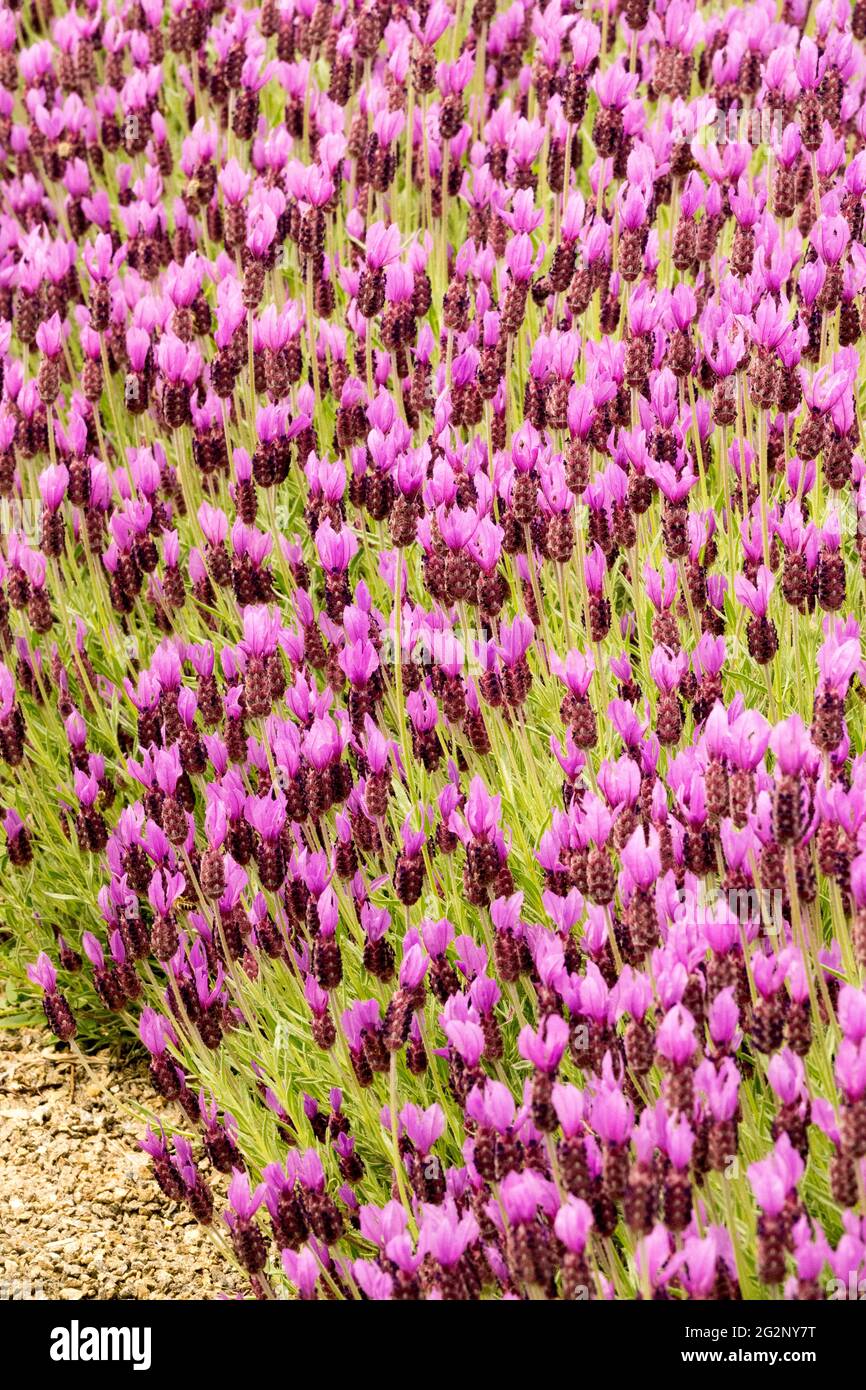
8,0,866,1300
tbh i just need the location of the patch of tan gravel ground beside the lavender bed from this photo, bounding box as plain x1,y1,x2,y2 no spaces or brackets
0,1031,239,1298
